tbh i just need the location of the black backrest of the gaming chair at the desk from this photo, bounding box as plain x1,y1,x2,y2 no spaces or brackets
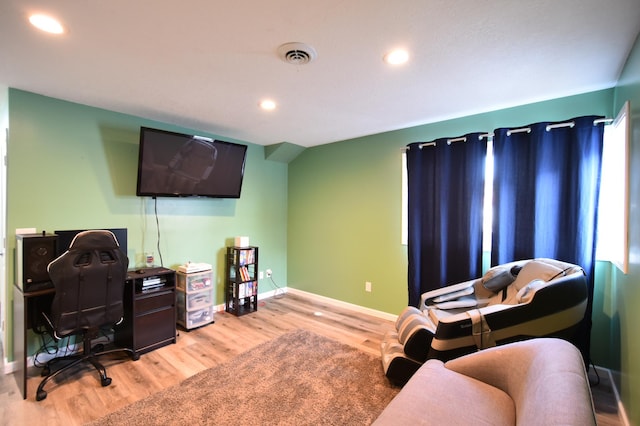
47,230,129,336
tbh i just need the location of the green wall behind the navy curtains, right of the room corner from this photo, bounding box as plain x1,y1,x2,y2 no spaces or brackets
287,90,613,314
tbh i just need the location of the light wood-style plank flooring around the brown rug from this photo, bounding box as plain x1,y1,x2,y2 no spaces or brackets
0,293,622,426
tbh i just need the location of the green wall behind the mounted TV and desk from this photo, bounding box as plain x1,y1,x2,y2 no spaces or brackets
7,89,287,360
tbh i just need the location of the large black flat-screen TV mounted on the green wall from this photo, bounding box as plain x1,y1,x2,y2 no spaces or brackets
136,127,247,198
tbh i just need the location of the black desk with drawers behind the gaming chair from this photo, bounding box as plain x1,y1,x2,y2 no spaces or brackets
13,268,176,399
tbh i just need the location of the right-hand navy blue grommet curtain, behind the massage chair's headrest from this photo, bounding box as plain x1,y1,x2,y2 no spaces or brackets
491,116,604,362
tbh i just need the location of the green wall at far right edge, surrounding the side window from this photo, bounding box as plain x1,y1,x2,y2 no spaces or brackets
602,31,640,425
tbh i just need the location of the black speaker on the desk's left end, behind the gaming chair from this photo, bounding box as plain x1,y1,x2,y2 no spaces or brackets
16,234,58,292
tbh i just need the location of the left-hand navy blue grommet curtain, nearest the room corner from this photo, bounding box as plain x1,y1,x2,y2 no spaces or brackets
407,133,487,307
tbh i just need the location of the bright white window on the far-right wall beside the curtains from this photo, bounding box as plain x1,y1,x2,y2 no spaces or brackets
596,101,630,274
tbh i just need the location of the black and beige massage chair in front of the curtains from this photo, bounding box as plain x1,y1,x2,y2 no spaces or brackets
381,258,588,386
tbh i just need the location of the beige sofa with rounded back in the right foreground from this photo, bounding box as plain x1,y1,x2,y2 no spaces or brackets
374,338,596,426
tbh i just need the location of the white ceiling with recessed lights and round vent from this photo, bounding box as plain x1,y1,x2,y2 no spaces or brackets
0,0,640,147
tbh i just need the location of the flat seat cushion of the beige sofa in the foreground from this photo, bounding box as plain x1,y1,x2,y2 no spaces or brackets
373,359,516,426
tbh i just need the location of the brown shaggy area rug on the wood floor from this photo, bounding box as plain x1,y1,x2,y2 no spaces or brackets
92,330,399,425
